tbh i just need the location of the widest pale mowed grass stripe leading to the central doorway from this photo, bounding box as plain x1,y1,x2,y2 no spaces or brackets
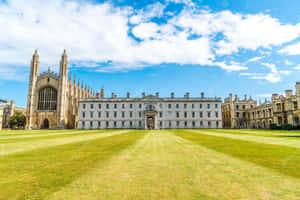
46,130,300,200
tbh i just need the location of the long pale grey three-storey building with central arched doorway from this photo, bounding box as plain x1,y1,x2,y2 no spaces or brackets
79,90,222,129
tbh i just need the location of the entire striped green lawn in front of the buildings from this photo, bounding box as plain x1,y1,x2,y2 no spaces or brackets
0,129,300,200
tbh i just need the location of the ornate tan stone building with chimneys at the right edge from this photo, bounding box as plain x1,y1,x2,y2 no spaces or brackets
222,82,300,128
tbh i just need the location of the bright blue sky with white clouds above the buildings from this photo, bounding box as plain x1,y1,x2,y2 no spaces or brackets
0,0,300,106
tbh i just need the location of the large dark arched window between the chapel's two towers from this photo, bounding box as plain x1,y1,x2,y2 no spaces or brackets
38,87,57,111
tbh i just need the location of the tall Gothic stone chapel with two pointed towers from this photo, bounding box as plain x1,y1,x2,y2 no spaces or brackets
26,50,95,129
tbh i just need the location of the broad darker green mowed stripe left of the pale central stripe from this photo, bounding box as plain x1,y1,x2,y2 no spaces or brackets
0,131,144,200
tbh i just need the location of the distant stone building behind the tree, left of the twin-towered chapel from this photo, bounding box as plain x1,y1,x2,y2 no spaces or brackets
0,99,26,128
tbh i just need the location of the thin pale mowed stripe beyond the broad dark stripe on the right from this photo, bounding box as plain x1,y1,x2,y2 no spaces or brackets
185,130,300,148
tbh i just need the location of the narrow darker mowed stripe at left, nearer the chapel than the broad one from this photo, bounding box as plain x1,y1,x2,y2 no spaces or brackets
0,130,117,144
